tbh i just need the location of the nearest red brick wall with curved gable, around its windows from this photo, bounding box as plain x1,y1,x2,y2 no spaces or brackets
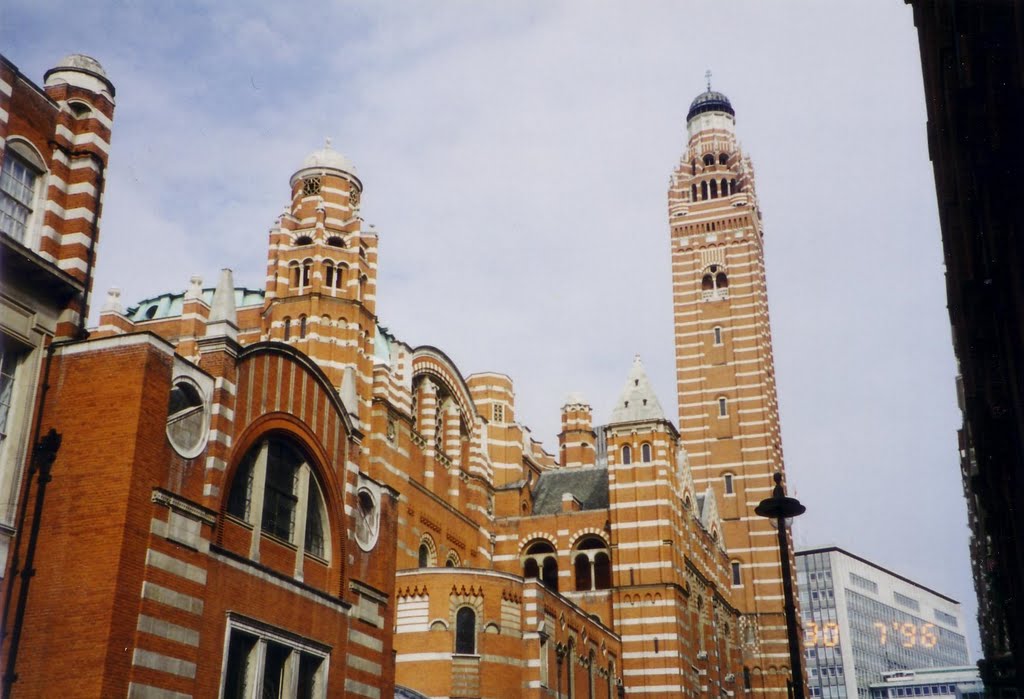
7,327,398,698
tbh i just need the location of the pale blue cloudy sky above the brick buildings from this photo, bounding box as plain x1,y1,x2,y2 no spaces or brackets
0,0,980,654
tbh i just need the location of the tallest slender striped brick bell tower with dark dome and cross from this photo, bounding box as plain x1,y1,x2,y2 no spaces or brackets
669,80,796,697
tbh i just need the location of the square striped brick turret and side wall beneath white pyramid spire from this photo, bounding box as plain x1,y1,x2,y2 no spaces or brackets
605,413,741,696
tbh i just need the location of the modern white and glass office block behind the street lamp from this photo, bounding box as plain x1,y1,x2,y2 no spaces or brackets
797,547,970,699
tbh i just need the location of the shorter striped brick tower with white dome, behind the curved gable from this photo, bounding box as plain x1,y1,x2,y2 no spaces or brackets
263,139,377,424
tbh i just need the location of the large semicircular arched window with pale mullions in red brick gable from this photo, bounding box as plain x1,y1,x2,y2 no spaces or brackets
227,436,329,558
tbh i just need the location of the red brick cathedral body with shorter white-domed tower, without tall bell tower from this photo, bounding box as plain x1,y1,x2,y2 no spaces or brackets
5,51,790,699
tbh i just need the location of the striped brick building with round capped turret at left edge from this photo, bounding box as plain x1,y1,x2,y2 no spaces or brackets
0,55,114,646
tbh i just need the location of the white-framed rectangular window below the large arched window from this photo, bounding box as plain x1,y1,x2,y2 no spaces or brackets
218,612,331,699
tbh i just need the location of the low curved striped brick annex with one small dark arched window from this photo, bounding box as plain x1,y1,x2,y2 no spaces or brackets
395,568,622,699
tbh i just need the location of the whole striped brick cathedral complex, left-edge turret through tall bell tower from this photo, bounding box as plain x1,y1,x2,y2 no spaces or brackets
0,56,790,699
